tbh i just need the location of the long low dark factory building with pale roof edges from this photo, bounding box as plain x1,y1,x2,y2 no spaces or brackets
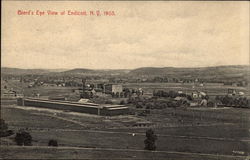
17,98,129,116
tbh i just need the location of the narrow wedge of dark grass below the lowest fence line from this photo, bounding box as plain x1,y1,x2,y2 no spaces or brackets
1,147,249,160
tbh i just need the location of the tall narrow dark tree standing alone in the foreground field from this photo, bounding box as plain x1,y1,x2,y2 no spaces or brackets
144,129,157,150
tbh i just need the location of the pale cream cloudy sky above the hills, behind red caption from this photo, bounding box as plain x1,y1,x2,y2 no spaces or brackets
1,1,250,69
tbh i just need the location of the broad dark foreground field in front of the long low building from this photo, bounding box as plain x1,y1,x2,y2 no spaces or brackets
1,102,250,160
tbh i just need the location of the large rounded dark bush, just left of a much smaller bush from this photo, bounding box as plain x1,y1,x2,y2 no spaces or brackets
15,130,32,146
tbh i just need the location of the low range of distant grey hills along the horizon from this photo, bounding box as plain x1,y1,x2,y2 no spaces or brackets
1,65,250,79
